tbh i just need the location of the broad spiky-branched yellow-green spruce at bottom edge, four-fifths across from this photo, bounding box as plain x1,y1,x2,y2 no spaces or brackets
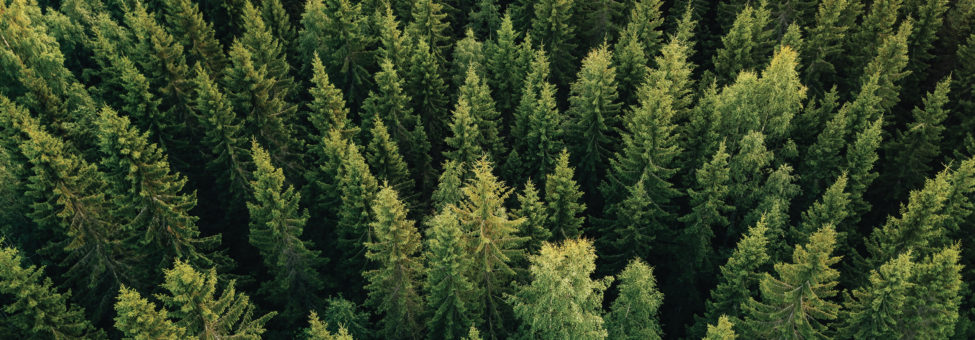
745,225,840,339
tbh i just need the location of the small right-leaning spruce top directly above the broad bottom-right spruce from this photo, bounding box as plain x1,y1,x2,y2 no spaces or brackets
790,173,850,243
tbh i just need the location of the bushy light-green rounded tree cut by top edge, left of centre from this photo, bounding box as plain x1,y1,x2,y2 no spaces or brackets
297,0,375,103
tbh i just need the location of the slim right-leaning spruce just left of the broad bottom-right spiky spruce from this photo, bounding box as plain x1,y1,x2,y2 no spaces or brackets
691,219,771,337
